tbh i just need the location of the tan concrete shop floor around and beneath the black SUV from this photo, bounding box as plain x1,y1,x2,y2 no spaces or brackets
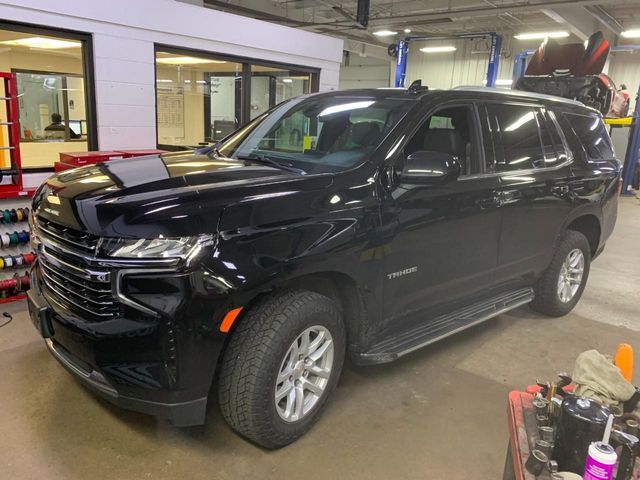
0,198,640,480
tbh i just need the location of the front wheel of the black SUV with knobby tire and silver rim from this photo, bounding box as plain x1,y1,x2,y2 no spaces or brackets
218,290,346,448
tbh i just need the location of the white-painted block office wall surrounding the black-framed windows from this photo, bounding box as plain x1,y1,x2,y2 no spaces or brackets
0,0,342,150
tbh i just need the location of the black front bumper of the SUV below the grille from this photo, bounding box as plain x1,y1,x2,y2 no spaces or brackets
29,262,230,426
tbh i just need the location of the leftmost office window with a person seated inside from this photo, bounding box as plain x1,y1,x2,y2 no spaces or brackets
0,27,94,170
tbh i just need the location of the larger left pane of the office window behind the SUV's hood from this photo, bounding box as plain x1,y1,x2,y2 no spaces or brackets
156,50,243,148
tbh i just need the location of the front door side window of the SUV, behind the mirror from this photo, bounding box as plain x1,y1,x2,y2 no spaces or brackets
404,106,480,175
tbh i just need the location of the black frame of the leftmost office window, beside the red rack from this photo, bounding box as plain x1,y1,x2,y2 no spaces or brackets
0,20,98,167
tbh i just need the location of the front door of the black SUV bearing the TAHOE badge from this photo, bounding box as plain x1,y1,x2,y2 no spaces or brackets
383,103,500,328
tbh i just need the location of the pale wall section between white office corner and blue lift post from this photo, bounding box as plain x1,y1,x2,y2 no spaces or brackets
340,52,395,90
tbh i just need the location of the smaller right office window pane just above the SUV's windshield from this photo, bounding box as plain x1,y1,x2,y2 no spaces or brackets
250,65,311,119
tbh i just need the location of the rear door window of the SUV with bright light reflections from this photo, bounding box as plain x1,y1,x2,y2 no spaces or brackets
487,105,553,172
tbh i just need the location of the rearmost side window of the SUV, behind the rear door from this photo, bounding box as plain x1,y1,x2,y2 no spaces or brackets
559,113,615,160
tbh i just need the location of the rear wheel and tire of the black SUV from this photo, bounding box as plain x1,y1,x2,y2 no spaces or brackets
530,230,591,317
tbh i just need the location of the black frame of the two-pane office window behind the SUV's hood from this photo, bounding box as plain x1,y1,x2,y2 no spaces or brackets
153,43,320,150
